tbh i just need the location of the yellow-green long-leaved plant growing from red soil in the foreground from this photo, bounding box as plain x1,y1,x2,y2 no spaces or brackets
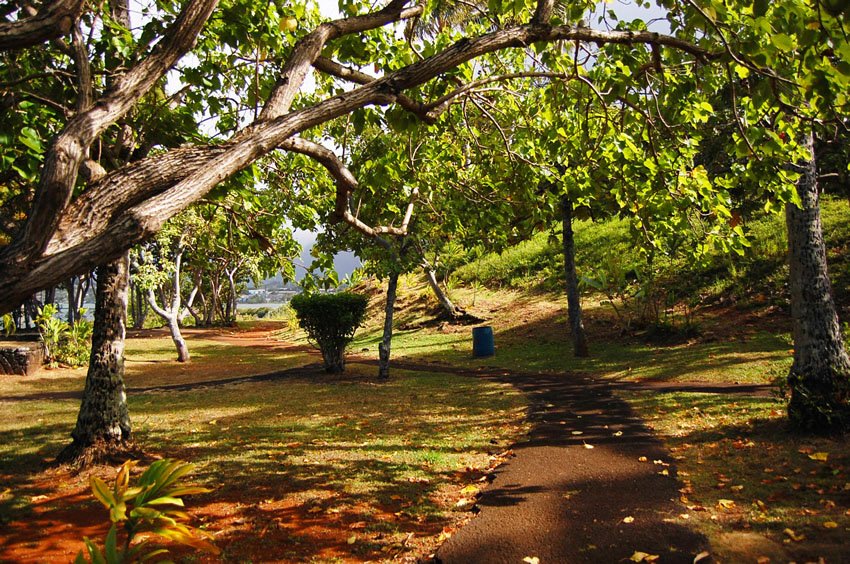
75,459,219,564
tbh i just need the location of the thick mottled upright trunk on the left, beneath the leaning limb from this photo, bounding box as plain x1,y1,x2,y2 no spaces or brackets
57,254,131,466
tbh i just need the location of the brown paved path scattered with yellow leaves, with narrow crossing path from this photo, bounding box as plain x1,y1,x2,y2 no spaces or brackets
336,361,708,564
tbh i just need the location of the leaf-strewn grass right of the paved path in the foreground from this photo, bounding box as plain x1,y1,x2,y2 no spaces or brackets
624,392,850,562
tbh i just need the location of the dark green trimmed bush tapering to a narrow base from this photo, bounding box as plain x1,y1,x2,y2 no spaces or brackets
290,292,369,372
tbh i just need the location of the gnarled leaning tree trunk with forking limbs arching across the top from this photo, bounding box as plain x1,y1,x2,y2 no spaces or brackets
0,0,707,311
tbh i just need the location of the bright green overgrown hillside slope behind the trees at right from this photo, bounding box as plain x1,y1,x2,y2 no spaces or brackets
453,199,850,316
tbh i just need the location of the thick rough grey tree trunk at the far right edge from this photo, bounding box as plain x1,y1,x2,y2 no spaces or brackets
785,135,850,432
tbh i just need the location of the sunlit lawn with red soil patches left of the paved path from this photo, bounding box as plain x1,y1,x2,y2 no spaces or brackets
0,328,526,561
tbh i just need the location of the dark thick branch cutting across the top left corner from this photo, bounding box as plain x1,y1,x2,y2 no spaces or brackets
0,0,85,51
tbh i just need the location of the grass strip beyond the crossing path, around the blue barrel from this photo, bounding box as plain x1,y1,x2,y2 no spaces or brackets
351,308,791,384
